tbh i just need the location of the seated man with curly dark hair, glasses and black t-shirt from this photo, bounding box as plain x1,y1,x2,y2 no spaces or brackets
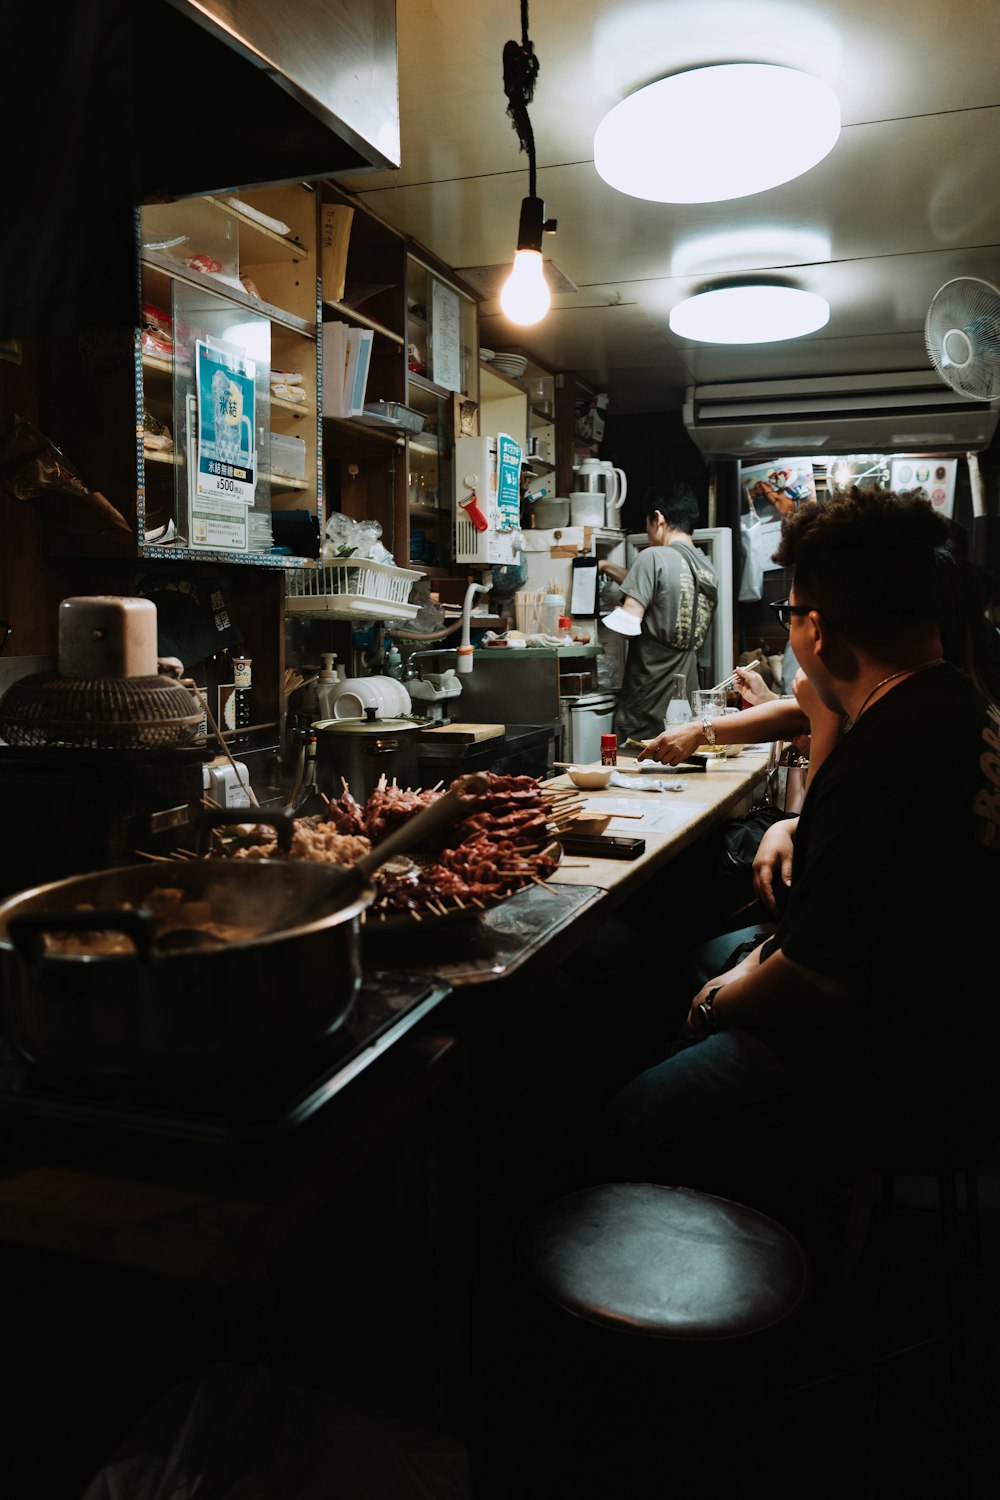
610,491,1000,1212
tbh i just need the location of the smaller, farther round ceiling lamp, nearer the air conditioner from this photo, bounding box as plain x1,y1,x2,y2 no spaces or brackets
670,282,831,344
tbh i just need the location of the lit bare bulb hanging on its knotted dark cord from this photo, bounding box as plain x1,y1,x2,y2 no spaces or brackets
501,0,556,326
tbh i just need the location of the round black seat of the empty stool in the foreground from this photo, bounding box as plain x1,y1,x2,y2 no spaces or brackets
520,1182,810,1343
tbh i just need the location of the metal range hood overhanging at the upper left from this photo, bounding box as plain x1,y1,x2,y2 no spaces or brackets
148,0,400,198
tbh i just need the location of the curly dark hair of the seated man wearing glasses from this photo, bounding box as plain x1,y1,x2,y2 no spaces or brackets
774,486,948,647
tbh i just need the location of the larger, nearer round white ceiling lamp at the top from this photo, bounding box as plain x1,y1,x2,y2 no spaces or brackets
594,63,840,203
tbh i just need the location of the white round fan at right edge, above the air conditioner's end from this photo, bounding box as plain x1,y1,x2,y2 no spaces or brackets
924,276,1000,401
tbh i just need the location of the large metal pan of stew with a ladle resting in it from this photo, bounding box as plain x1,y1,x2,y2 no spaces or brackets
0,777,484,1076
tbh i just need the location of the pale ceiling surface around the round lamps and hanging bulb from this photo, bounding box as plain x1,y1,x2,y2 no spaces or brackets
343,0,1000,413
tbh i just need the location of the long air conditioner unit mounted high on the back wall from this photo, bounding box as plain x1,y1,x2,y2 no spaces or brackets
684,368,1000,459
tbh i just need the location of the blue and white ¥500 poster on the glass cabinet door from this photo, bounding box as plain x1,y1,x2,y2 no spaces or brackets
195,339,256,506
